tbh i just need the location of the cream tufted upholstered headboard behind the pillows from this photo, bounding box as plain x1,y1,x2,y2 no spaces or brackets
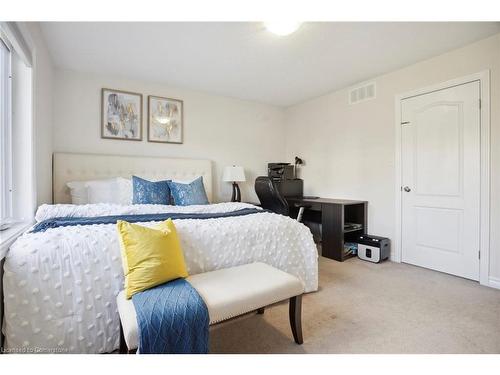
52,152,212,203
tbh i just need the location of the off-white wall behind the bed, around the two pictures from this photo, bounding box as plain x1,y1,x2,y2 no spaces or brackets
53,70,285,201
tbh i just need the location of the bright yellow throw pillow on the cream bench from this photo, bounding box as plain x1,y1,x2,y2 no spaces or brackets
116,219,188,299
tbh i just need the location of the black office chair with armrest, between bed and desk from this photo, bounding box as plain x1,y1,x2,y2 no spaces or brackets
255,176,308,222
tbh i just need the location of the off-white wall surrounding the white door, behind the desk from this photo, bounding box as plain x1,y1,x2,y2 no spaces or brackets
285,34,500,278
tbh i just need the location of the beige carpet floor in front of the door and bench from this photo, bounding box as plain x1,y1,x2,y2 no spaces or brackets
210,258,500,353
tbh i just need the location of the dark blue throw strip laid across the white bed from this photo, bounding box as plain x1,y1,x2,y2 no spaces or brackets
31,208,269,233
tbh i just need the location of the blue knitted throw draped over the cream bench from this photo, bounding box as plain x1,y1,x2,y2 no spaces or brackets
132,279,210,354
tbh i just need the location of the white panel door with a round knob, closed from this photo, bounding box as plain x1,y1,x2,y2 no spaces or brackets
401,81,480,280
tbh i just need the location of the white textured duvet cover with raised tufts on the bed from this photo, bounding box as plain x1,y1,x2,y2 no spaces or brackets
3,203,318,353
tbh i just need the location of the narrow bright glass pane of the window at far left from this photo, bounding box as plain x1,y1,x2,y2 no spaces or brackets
0,39,13,230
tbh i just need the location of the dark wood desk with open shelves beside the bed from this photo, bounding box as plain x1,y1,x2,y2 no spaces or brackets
286,197,368,262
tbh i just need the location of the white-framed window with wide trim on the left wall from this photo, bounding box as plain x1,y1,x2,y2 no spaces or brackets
0,22,35,238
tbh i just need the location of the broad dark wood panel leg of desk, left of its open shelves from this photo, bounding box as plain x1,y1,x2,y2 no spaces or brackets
321,204,344,262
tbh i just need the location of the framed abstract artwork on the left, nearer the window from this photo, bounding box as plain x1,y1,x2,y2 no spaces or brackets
101,88,142,141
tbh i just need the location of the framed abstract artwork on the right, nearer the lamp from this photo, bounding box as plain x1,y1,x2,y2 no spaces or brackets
148,95,183,143
